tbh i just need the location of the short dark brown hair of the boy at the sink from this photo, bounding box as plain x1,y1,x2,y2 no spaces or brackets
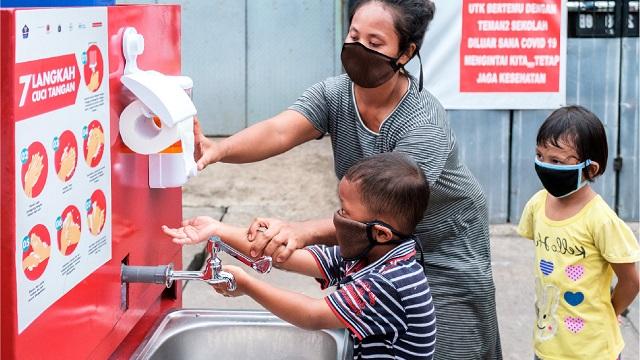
344,152,429,234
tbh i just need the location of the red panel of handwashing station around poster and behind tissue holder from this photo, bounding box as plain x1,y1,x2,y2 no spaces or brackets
0,5,182,359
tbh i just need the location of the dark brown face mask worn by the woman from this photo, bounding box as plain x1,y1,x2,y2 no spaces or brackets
340,42,422,91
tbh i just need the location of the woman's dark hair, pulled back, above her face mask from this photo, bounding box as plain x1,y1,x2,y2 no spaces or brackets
349,0,436,57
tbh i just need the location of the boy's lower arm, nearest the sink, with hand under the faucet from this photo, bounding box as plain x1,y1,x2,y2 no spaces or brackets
216,266,345,330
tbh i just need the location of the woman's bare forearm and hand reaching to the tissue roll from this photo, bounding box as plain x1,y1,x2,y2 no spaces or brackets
195,110,322,169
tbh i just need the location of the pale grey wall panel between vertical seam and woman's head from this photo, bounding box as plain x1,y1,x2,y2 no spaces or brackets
246,0,339,125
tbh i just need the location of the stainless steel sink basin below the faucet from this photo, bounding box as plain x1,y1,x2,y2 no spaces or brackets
132,309,353,360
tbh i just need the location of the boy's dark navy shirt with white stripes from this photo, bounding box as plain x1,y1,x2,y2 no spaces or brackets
307,240,436,359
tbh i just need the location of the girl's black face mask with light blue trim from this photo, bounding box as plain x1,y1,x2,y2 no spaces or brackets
535,158,591,198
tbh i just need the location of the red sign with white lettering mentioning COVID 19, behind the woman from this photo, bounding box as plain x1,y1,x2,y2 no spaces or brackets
460,0,562,93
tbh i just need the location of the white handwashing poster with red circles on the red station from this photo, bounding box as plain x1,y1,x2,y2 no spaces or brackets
14,8,111,333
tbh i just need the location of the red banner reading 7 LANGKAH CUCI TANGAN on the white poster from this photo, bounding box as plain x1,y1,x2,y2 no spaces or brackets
15,54,81,121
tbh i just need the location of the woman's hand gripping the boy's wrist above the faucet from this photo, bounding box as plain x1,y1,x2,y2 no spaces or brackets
247,218,306,262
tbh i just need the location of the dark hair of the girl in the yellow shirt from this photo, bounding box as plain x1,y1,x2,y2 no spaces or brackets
536,105,608,181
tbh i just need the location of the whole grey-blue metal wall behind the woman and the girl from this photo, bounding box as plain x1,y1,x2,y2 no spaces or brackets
118,0,640,223
